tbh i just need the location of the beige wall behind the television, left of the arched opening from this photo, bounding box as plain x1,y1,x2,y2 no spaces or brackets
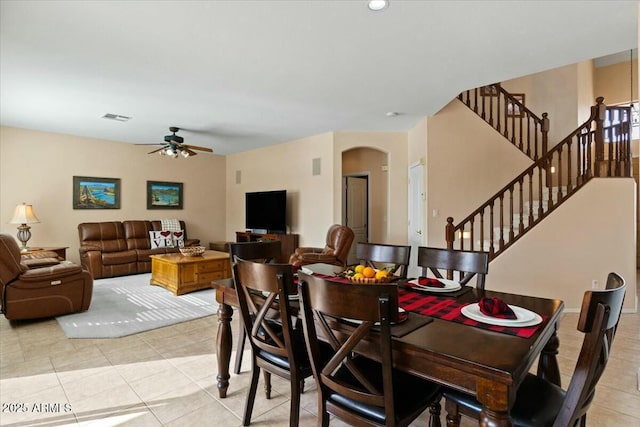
226,133,340,246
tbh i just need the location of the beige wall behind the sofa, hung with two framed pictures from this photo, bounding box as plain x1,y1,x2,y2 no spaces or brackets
0,127,226,262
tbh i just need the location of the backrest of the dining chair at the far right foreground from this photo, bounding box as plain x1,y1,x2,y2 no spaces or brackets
554,273,626,427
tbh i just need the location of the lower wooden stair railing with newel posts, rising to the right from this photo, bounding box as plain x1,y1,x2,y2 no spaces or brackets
445,97,631,259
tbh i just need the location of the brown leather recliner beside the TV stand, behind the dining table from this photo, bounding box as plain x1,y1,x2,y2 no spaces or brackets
289,224,353,267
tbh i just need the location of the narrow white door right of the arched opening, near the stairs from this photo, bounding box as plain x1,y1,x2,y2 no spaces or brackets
408,163,426,277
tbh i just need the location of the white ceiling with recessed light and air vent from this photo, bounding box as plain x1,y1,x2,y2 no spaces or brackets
0,0,639,155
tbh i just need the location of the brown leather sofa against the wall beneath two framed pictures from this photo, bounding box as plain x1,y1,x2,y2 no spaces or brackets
78,220,200,279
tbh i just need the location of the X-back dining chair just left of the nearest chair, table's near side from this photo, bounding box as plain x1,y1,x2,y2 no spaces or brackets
233,257,313,426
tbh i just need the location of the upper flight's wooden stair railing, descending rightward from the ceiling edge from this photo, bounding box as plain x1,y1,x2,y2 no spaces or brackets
458,83,549,160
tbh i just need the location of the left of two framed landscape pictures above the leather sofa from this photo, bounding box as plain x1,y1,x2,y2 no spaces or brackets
73,176,120,209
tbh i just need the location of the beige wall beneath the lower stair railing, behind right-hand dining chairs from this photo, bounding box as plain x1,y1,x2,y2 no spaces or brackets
486,178,636,311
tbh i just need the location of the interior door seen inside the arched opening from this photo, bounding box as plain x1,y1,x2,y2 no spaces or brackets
343,176,369,265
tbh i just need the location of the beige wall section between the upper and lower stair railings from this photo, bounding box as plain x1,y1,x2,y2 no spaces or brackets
425,99,532,247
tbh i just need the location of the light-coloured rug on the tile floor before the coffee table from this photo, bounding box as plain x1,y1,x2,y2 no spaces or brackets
56,273,218,338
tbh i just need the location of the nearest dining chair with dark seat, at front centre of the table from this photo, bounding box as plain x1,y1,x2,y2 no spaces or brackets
298,273,441,426
